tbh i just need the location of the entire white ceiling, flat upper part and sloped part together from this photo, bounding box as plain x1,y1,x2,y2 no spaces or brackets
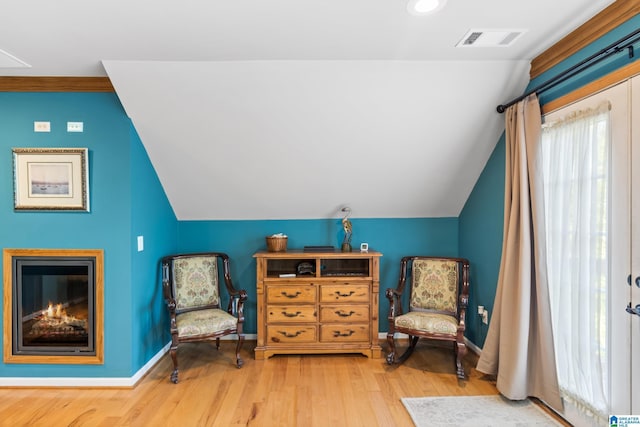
0,0,612,220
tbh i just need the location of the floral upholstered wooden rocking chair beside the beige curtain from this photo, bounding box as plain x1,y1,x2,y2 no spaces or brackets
386,256,469,379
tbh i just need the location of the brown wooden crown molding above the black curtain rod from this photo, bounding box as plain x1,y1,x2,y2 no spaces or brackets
529,0,640,79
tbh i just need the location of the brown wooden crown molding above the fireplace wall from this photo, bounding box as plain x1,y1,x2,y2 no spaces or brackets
0,76,115,92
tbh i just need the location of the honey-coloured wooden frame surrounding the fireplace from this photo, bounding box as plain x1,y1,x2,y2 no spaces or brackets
2,249,104,365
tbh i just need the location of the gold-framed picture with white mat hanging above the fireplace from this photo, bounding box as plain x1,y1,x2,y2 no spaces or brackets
13,148,89,212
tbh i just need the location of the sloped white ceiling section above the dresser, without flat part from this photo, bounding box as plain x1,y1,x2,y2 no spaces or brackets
105,61,528,219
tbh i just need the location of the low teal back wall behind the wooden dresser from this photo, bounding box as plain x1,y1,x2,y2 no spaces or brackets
178,218,458,333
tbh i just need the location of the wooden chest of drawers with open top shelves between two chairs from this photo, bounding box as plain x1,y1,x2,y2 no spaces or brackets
254,250,382,359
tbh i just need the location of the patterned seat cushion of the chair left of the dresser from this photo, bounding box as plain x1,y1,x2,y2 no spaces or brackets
176,308,238,338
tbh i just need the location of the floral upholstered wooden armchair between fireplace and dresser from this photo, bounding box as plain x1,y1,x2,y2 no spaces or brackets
162,252,247,383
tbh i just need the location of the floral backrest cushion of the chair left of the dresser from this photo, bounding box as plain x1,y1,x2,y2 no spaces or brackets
173,256,219,310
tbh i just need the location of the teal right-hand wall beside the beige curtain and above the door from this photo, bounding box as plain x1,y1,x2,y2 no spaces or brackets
459,16,640,347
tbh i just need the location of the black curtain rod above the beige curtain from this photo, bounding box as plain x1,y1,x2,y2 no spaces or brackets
496,29,640,113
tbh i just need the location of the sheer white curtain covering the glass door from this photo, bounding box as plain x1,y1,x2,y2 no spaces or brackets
537,103,611,420
